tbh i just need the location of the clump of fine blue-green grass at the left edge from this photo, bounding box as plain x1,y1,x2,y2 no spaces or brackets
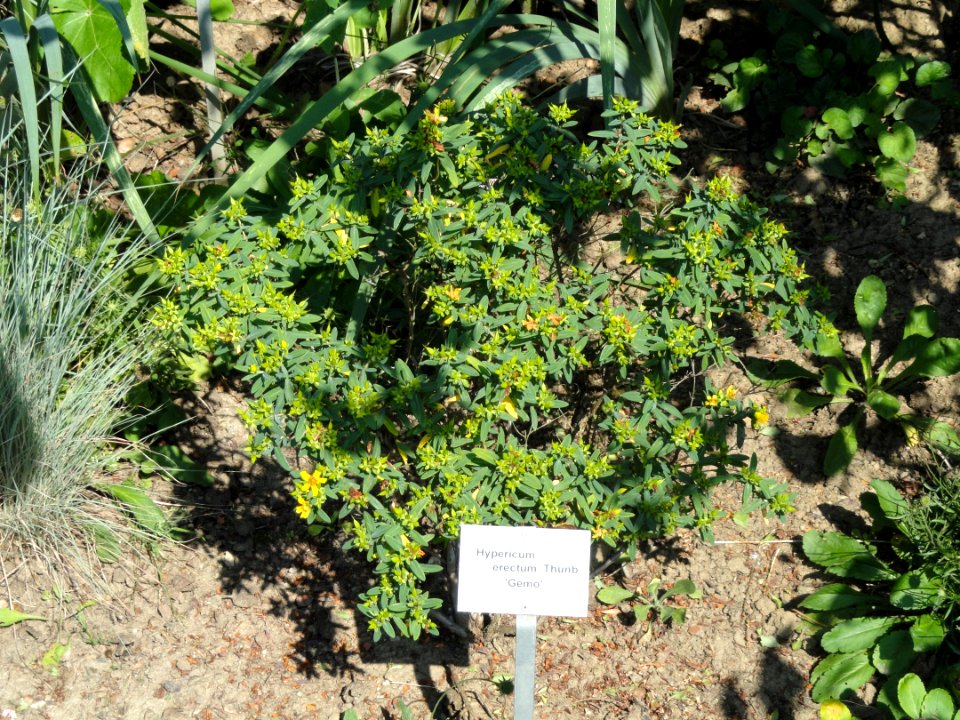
0,143,163,587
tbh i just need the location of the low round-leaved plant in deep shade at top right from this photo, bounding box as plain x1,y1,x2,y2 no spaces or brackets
706,0,960,193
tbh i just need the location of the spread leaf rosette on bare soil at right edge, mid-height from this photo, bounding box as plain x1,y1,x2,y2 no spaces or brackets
747,275,960,475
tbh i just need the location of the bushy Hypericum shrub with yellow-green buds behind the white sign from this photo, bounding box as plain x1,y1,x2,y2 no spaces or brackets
154,94,810,639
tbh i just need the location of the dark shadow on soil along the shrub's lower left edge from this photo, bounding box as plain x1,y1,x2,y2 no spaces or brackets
169,388,467,718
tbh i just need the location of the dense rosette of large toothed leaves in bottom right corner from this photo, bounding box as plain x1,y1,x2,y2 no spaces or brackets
800,480,960,718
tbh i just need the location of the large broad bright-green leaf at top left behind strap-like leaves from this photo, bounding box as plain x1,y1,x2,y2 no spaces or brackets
50,0,134,103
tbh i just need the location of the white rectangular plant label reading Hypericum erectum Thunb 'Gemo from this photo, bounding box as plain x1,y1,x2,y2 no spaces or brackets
457,525,590,617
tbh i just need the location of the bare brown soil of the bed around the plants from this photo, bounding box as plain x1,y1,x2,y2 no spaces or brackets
0,3,960,720
